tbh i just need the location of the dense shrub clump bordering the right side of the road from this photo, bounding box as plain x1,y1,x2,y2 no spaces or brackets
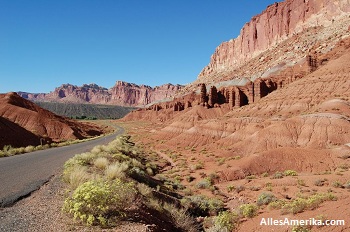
63,136,199,231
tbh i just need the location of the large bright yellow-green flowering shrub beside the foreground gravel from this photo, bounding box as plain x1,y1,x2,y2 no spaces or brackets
63,179,136,225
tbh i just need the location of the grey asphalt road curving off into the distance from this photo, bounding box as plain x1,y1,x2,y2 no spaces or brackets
0,127,124,207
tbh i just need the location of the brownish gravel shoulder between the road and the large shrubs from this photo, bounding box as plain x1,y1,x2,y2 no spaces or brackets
0,170,147,232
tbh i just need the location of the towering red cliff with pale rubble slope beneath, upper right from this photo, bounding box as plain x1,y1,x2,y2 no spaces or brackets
194,0,350,82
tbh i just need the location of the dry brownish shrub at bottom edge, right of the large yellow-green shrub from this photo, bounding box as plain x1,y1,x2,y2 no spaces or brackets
163,203,199,232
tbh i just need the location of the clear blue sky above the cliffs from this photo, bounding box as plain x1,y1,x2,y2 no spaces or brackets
0,0,277,93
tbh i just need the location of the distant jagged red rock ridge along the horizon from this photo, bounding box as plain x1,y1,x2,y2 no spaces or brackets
18,81,183,106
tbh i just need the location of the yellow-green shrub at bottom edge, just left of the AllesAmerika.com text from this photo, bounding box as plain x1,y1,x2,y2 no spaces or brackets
214,211,239,231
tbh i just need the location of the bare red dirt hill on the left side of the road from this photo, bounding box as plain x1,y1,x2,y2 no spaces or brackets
0,93,102,148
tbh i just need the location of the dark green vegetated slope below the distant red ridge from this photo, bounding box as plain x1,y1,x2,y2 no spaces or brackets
35,102,136,120
